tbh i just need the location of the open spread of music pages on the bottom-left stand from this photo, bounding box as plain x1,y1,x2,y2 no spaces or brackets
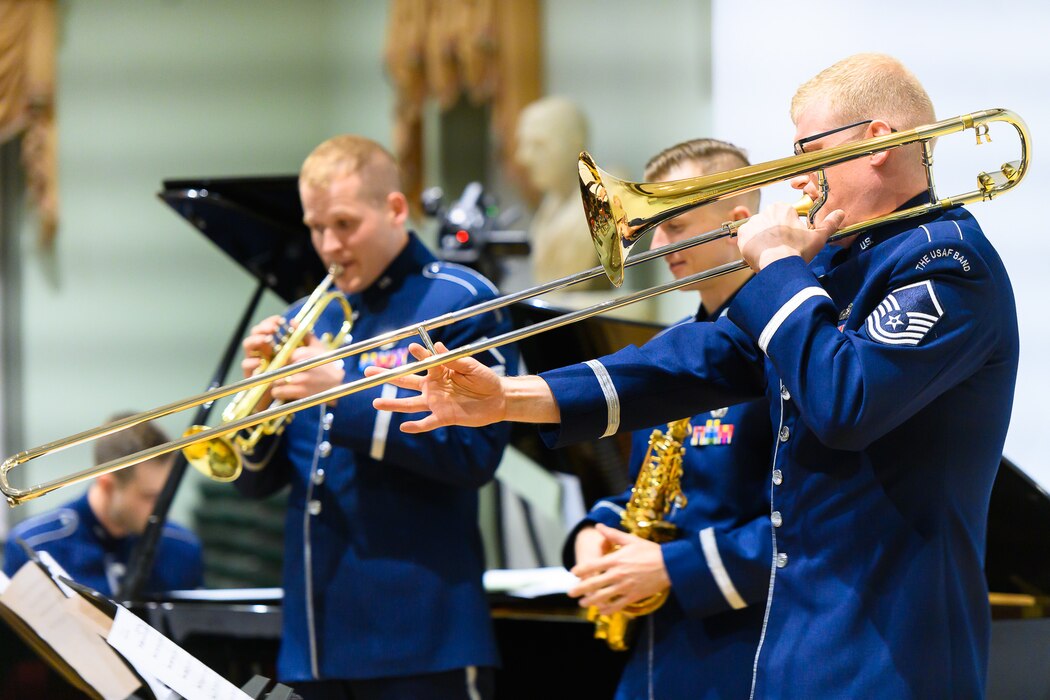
0,552,257,700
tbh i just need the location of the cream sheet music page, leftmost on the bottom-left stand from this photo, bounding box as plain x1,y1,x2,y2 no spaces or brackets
0,561,141,700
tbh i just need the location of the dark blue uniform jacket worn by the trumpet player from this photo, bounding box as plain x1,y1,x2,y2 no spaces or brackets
236,236,518,681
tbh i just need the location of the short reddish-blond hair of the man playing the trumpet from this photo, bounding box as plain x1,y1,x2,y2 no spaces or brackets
299,134,401,200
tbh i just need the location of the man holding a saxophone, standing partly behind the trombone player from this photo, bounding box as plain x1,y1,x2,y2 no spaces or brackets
565,139,773,700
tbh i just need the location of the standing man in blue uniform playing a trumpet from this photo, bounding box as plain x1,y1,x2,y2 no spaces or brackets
235,135,518,700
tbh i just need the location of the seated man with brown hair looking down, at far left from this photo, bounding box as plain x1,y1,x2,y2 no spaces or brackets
3,412,204,597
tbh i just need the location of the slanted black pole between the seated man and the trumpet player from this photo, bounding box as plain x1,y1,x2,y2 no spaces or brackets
113,279,266,601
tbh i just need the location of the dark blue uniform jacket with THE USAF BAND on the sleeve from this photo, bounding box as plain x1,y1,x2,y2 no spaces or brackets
544,203,1017,699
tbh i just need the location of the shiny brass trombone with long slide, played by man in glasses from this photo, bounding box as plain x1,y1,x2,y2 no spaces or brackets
0,109,1031,506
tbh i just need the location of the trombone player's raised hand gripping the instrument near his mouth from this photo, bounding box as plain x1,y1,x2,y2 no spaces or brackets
736,203,845,272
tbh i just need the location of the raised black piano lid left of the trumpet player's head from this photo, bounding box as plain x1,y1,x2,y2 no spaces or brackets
158,175,324,303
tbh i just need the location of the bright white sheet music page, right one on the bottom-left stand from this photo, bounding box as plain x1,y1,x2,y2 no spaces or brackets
106,607,251,700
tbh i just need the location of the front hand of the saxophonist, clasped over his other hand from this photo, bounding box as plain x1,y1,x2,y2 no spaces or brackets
568,524,671,615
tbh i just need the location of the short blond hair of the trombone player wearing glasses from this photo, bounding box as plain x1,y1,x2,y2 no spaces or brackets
791,54,936,130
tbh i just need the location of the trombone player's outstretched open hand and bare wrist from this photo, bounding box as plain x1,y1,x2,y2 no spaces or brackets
364,343,560,433
